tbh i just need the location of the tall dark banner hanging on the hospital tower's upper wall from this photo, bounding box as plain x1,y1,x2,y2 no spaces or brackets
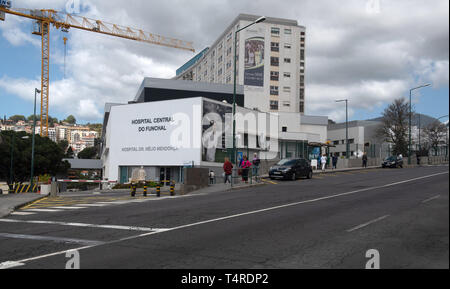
244,37,264,87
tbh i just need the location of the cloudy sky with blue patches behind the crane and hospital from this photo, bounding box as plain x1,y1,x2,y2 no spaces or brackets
0,0,449,122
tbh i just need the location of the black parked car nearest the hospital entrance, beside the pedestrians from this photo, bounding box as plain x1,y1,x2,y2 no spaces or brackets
269,159,312,180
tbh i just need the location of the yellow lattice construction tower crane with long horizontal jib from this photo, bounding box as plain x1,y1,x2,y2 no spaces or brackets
0,0,195,136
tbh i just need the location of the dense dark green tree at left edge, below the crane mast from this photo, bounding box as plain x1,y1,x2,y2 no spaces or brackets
0,131,70,182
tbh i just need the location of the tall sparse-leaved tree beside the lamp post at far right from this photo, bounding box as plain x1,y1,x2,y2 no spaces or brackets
377,98,409,156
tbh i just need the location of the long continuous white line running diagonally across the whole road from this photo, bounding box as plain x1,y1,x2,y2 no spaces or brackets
0,171,449,266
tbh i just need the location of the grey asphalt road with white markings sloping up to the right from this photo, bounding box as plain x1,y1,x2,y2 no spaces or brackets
0,166,449,269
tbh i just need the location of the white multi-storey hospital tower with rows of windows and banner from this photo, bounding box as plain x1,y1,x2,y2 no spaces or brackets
175,14,306,114
